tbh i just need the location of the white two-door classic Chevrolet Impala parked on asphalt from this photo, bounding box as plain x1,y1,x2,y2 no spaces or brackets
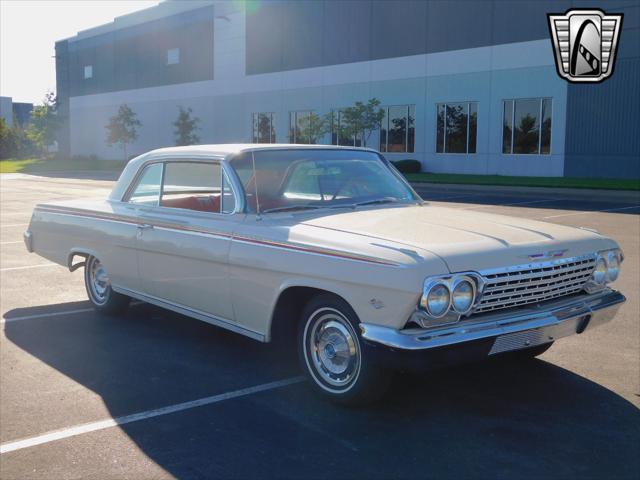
25,145,625,403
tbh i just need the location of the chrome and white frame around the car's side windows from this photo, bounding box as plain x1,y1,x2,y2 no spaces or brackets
120,157,244,215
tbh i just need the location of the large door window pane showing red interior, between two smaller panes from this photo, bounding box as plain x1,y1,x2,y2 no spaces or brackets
160,161,225,213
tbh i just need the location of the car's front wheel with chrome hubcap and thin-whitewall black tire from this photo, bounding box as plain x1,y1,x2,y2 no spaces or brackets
298,295,389,405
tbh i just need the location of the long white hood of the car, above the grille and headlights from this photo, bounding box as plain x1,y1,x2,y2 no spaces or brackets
302,204,617,272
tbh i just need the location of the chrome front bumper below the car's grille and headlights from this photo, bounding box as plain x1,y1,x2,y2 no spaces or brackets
360,290,626,355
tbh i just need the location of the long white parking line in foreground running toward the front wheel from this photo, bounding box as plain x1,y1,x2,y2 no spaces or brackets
0,377,304,455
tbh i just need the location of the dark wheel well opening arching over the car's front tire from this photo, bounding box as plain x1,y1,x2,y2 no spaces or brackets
271,287,344,342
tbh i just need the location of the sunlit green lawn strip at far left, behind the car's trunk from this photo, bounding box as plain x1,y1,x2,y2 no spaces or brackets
0,158,125,173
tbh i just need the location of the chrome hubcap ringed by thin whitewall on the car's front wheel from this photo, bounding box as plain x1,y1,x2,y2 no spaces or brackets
306,310,360,388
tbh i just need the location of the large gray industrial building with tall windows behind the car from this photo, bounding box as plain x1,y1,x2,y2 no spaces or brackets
56,0,640,178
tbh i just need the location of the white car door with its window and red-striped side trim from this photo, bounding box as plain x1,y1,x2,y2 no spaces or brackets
127,159,238,321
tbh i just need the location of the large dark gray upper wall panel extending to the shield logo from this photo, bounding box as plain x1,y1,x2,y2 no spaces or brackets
246,0,571,75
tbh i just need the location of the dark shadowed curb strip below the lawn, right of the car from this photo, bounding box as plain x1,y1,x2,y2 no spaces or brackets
410,182,640,205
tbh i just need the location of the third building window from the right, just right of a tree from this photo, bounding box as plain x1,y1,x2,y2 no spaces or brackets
380,105,416,153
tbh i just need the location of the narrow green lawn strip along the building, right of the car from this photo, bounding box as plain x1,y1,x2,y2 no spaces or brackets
405,173,640,191
